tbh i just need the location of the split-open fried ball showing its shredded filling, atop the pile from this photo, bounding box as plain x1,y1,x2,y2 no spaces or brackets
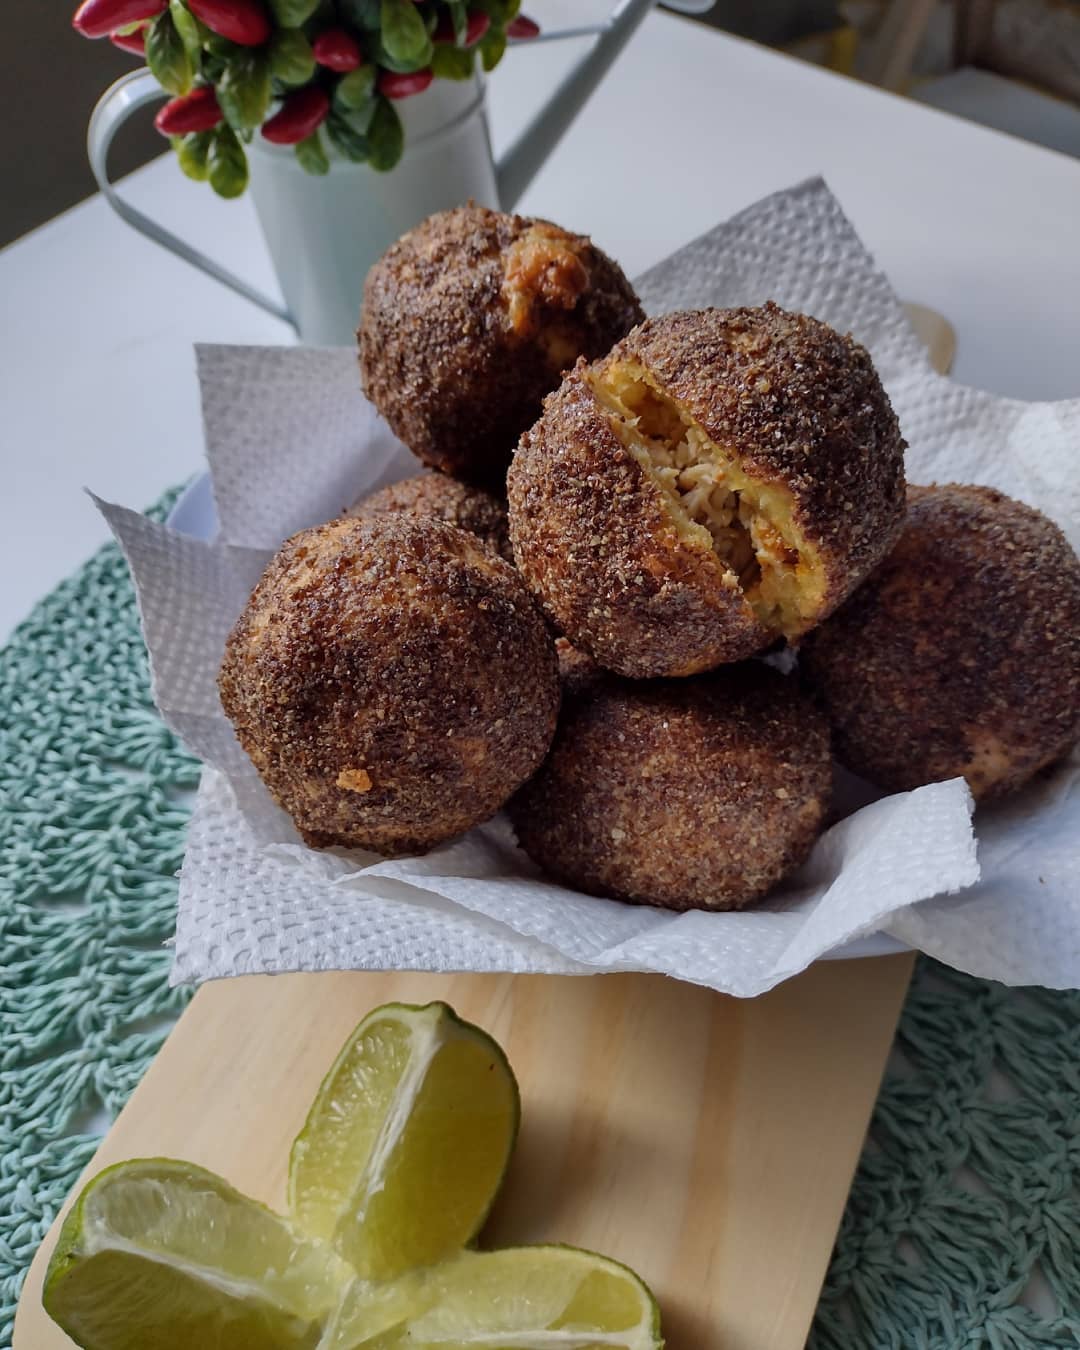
508,304,905,679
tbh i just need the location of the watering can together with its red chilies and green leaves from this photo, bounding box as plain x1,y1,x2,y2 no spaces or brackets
73,0,653,344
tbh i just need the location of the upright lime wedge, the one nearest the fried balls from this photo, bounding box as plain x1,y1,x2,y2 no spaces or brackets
289,1003,520,1280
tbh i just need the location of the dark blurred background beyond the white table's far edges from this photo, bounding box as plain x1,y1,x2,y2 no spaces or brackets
8,0,1080,247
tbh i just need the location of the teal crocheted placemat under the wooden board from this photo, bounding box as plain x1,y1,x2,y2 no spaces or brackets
0,494,1080,1350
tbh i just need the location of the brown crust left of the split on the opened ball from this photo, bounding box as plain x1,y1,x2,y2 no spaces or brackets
508,362,771,679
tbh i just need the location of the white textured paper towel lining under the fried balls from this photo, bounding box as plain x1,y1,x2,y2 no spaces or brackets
100,180,1080,996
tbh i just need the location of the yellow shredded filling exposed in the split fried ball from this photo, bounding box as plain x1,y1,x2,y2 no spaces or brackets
594,365,824,636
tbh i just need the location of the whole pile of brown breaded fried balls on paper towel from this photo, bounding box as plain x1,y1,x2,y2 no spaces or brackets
219,205,1080,910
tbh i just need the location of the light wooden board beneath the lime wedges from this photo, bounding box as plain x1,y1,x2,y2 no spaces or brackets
15,956,913,1350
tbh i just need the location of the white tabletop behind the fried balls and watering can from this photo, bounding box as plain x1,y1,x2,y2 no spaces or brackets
0,0,1080,640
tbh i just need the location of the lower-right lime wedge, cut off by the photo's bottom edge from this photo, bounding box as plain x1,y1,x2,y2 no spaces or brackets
320,1247,663,1350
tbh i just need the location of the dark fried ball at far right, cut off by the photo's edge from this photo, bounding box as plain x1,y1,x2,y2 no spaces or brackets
799,483,1080,801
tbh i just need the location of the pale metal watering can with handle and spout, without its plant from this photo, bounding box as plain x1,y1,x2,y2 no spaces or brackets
88,0,713,346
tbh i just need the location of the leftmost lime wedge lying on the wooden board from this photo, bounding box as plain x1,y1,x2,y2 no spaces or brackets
42,1158,351,1350
